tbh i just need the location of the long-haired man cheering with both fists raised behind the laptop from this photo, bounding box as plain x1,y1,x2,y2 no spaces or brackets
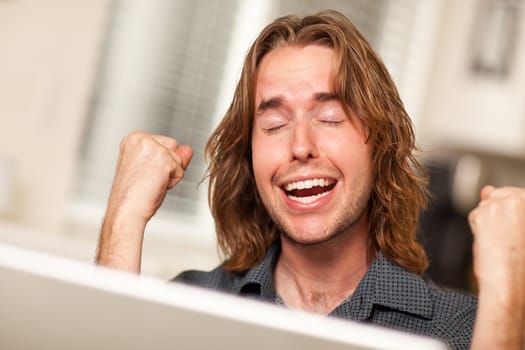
97,11,525,349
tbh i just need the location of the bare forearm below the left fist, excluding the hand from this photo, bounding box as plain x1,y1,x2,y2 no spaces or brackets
96,211,145,273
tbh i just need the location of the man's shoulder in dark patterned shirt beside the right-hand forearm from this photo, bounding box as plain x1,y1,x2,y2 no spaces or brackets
372,254,477,349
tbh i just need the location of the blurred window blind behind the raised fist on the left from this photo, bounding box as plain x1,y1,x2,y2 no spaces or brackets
75,0,238,214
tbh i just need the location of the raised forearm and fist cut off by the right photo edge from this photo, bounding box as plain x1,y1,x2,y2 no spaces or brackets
469,186,525,350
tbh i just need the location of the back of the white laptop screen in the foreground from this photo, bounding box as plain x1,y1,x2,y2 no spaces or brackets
0,244,446,350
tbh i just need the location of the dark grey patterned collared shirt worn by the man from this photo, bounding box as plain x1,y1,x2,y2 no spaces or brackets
174,243,477,349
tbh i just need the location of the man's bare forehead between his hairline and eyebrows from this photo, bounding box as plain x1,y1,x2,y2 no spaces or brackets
255,45,334,101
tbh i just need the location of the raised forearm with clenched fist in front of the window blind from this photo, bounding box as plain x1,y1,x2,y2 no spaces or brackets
96,132,193,273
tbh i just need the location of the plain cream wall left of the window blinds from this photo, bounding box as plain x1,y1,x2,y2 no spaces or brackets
0,0,109,232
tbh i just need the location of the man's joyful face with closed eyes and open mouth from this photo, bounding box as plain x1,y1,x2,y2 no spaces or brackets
252,45,372,244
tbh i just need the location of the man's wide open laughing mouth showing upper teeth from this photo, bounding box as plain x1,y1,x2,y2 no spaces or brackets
283,179,336,204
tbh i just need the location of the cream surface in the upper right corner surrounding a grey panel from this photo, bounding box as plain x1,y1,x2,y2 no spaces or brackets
418,0,525,156
